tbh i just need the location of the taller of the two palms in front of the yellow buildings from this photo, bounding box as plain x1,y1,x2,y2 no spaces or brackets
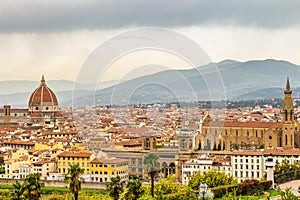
65,164,84,200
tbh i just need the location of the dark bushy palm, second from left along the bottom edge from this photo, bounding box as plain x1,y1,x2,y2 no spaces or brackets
22,173,43,200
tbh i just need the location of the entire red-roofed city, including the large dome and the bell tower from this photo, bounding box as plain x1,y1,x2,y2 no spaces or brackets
0,77,300,184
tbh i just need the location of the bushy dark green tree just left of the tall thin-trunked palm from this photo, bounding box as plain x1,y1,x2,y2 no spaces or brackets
120,178,145,200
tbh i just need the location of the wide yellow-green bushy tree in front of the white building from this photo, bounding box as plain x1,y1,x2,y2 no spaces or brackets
188,169,237,190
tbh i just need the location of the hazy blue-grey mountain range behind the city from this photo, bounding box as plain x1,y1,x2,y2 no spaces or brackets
0,59,300,107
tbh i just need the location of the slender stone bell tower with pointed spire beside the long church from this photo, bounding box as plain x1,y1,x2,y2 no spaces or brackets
282,78,295,148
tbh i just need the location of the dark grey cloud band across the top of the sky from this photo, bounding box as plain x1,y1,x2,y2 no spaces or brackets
0,0,300,32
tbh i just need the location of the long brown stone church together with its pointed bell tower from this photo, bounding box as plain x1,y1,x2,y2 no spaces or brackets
195,79,300,151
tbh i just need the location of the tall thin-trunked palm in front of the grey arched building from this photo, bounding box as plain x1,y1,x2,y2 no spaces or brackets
144,153,160,197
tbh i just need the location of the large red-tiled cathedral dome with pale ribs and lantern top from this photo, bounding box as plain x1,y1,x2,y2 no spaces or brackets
28,76,58,106
